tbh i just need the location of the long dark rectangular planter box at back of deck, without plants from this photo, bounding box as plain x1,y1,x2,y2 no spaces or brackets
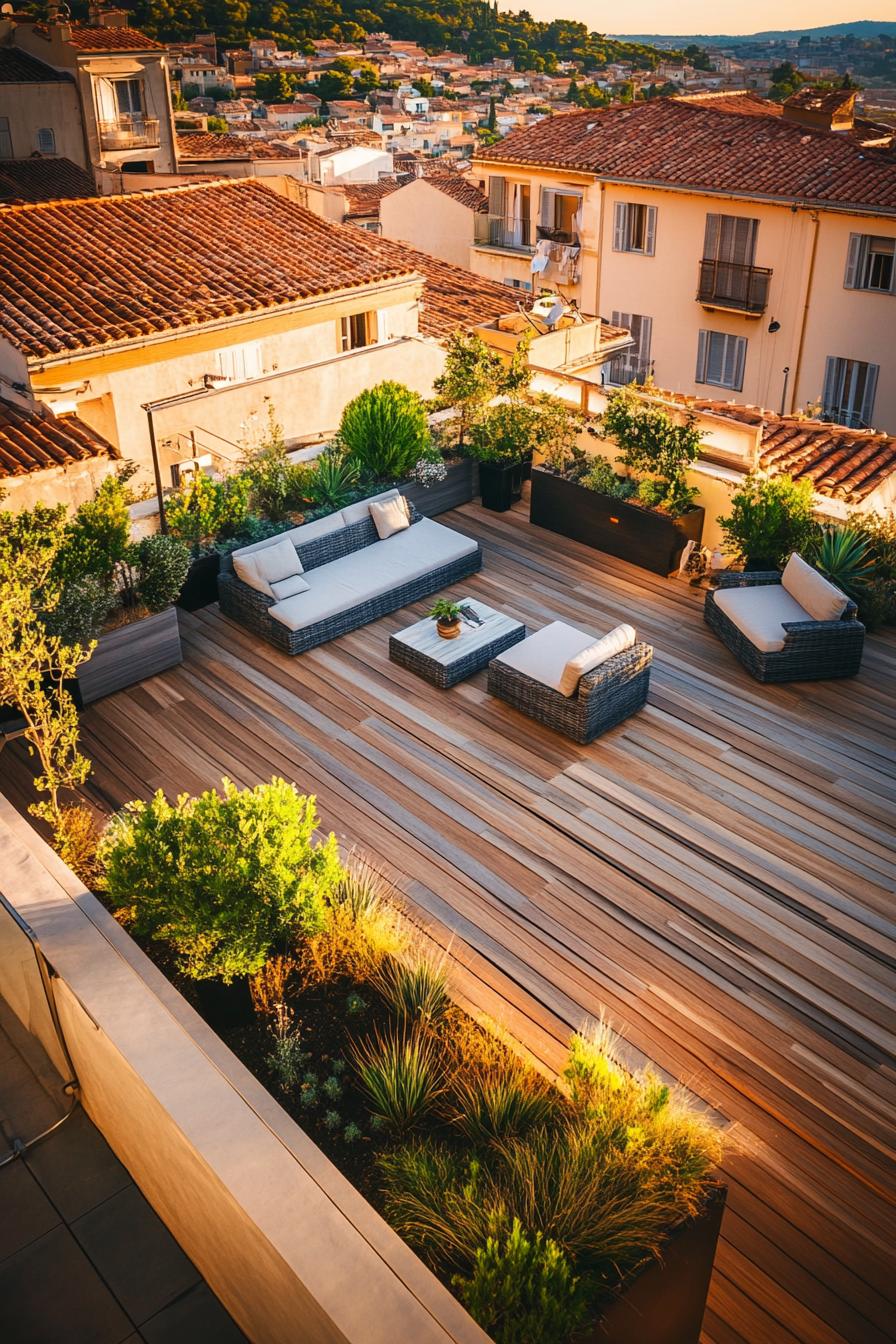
529,468,704,574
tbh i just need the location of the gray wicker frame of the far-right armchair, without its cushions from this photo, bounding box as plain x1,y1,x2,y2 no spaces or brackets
703,570,865,681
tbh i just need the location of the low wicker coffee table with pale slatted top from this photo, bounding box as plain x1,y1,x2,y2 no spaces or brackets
390,597,525,689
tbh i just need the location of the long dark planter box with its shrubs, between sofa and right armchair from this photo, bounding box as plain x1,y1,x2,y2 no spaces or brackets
529,390,704,574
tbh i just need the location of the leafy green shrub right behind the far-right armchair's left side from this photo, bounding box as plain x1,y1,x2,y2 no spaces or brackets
717,476,815,573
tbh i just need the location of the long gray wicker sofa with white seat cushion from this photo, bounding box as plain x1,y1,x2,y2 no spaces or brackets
218,491,482,653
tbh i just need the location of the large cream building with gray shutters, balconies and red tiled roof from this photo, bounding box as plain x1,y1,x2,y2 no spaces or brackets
470,93,896,431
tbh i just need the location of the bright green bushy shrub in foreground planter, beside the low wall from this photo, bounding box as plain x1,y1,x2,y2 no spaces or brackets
101,780,344,984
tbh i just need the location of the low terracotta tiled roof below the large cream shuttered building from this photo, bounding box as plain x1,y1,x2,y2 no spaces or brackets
660,392,896,504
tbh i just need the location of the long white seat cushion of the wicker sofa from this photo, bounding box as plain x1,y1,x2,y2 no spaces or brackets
269,517,480,642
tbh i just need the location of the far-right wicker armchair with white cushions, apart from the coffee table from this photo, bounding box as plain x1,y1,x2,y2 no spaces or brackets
704,555,865,681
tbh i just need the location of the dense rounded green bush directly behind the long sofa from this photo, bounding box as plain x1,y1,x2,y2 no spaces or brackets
339,382,430,481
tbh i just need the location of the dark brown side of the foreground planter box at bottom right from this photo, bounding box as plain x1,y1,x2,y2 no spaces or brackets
596,1183,728,1344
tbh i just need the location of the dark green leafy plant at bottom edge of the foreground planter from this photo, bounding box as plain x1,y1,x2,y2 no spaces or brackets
451,1218,587,1344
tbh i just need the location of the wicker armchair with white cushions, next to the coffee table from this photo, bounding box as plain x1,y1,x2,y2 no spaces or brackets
488,621,653,743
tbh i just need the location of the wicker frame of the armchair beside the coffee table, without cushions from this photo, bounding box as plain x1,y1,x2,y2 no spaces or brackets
488,644,653,743
